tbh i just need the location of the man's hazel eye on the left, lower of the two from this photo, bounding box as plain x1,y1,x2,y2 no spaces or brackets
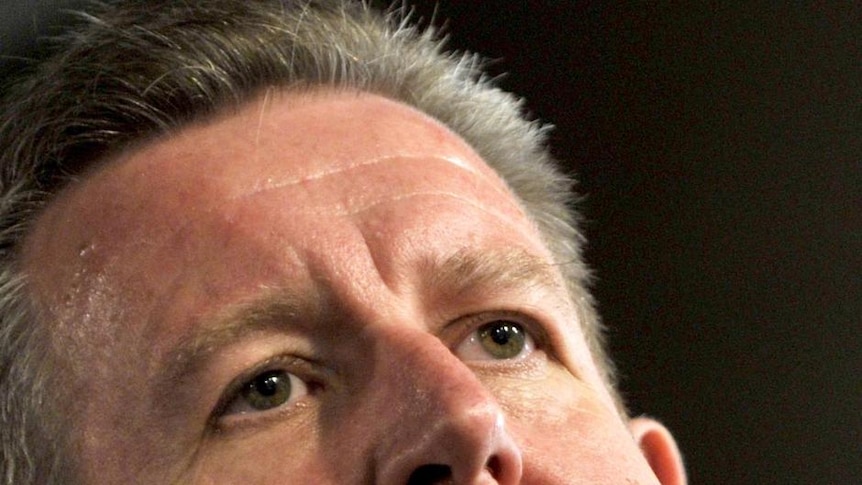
218,369,309,416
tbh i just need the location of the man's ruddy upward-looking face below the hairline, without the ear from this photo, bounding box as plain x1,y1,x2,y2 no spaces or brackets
24,92,680,484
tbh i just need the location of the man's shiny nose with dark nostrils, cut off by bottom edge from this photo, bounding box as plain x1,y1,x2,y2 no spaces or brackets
376,331,522,485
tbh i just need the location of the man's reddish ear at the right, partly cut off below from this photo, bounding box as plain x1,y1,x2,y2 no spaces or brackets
629,417,687,485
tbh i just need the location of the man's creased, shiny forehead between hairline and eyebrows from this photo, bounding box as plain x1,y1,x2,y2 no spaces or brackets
25,92,544,342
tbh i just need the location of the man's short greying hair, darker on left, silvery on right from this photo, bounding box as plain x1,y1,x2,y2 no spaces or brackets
0,0,614,484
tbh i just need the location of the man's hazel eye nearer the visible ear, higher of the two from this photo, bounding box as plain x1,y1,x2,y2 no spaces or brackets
456,320,535,361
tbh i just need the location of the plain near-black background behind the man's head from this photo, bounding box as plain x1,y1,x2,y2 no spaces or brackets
0,0,862,484
